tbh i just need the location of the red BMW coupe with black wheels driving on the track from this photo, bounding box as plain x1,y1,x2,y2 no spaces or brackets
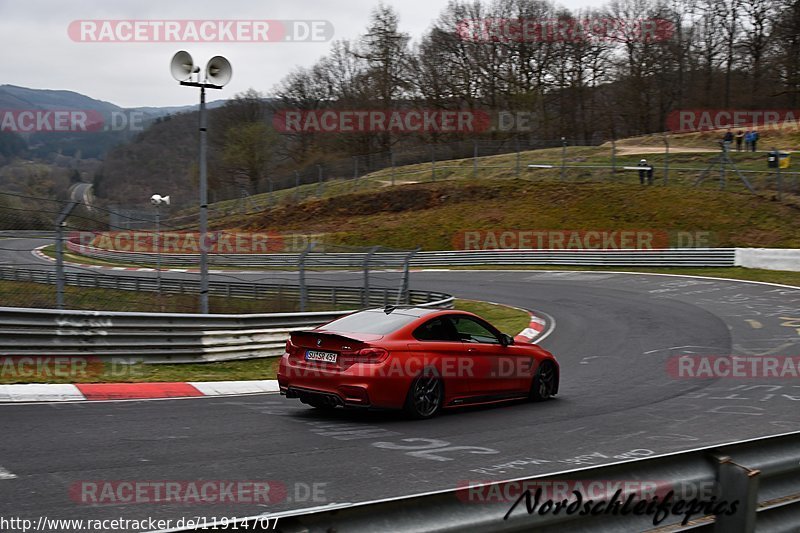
278,306,559,418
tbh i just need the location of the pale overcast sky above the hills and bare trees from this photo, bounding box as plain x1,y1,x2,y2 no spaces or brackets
0,0,605,107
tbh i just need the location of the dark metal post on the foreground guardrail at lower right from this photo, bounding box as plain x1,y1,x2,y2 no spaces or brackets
714,456,761,533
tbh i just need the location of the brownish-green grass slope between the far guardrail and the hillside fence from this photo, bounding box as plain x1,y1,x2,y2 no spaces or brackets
222,178,800,250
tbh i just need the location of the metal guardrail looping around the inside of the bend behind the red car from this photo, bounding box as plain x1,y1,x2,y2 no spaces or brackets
0,267,454,363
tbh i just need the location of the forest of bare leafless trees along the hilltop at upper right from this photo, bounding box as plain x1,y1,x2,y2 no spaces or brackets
270,0,800,161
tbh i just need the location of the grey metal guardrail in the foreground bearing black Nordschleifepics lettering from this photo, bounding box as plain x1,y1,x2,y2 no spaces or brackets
170,432,800,533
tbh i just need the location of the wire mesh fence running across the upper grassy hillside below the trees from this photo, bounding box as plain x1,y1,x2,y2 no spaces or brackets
159,135,800,226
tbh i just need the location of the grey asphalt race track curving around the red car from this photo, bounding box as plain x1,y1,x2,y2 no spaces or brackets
0,240,800,519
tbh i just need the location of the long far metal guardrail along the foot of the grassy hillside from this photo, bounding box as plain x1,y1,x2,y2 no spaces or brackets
67,242,736,268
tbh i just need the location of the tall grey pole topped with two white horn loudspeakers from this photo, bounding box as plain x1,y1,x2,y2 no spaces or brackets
170,51,233,314
